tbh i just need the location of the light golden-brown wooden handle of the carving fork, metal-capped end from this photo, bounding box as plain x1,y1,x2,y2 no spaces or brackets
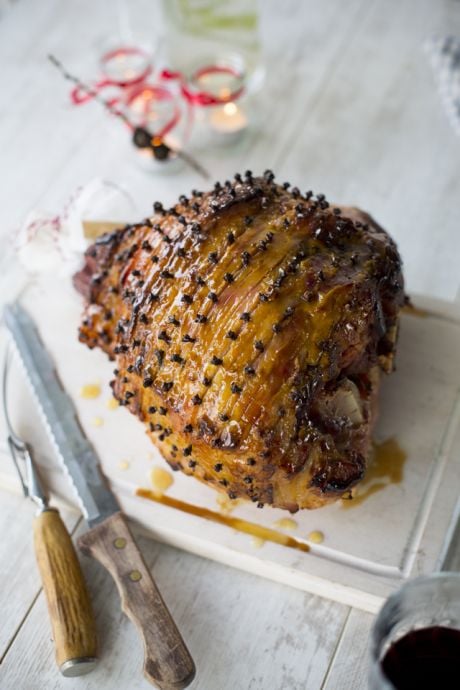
34,508,97,676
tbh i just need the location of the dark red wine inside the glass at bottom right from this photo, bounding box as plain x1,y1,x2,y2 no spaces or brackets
382,626,460,690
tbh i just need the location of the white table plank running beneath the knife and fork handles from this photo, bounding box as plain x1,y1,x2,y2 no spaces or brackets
0,520,348,690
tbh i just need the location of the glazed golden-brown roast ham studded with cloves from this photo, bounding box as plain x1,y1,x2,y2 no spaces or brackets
75,171,404,512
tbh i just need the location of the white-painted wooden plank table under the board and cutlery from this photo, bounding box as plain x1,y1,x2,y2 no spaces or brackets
0,0,460,690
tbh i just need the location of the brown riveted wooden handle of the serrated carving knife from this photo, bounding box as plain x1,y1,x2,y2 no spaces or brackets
78,513,195,690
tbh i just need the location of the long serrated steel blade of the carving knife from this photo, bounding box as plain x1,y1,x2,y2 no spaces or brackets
4,303,119,526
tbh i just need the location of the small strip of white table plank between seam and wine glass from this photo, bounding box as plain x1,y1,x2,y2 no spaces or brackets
323,609,374,690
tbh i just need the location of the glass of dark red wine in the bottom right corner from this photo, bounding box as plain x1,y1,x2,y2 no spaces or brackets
369,572,460,690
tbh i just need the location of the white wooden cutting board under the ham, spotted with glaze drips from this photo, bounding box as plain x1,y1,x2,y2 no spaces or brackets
0,279,460,612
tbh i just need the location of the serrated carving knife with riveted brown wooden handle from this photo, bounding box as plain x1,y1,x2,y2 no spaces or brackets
4,303,195,690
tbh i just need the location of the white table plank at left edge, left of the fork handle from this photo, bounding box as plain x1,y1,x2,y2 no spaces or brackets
0,490,80,656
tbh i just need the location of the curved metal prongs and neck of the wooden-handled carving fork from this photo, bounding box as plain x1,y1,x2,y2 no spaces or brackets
2,348,48,510
